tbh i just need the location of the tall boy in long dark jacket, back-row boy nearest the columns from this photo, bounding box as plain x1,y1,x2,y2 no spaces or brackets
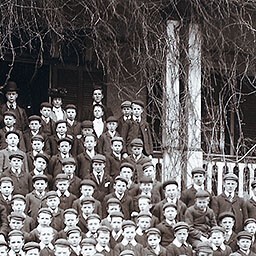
122,100,153,158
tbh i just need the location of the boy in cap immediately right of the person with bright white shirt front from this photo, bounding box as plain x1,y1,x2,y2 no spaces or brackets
97,116,120,155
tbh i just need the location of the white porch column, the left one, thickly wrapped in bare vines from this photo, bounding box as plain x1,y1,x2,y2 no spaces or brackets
162,20,181,185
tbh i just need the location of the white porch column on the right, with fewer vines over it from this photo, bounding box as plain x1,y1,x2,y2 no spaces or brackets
187,23,203,185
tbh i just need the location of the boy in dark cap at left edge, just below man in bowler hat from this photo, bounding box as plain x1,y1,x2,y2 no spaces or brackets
0,111,26,152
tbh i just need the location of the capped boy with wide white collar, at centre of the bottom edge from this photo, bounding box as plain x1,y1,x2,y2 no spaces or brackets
114,220,144,256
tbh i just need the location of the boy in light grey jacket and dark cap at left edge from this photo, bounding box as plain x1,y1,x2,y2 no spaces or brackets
0,131,29,172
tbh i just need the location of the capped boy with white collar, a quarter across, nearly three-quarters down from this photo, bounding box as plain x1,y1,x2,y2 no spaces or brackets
55,173,76,210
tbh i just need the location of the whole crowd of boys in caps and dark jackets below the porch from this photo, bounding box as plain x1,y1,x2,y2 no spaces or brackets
0,82,256,256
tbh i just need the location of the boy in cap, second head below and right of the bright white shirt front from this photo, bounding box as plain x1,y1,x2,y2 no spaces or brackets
106,137,124,179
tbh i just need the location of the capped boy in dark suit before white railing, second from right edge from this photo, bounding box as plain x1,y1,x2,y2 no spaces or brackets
211,173,248,233
